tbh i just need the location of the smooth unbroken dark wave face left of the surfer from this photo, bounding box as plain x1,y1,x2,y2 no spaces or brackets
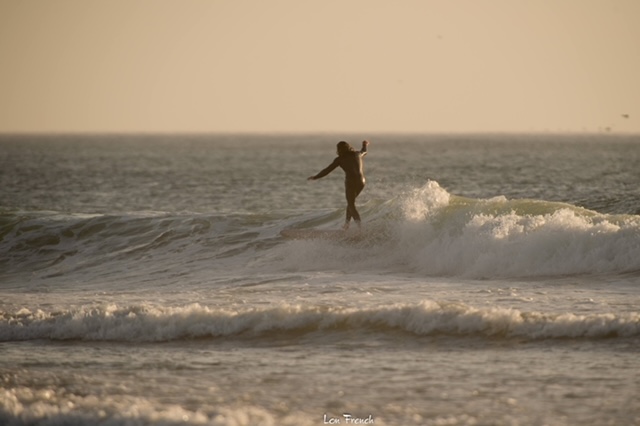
0,212,280,280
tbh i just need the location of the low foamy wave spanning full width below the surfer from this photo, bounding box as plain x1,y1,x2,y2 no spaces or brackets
0,300,640,342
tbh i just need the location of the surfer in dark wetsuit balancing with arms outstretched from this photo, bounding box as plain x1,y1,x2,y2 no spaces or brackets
308,141,369,230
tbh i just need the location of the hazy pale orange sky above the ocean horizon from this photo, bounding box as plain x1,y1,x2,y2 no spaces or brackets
0,0,640,133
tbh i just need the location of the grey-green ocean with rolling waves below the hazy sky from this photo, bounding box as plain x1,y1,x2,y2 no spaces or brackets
0,134,640,426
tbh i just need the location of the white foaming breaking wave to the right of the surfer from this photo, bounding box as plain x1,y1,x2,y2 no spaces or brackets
272,181,640,279
